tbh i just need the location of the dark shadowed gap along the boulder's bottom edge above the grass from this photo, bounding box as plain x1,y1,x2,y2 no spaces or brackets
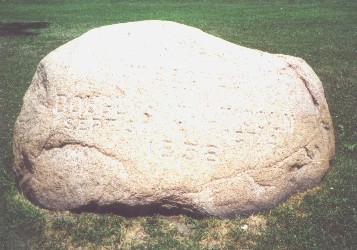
72,201,207,218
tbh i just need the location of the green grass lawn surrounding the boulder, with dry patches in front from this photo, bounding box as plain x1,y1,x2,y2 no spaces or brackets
0,0,357,249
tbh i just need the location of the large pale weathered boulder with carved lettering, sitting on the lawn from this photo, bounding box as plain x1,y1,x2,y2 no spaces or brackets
14,21,334,217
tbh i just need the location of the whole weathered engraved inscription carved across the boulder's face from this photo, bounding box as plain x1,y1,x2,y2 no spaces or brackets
52,92,294,164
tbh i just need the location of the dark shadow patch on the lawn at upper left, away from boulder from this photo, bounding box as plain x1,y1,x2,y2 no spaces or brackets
0,22,49,37
